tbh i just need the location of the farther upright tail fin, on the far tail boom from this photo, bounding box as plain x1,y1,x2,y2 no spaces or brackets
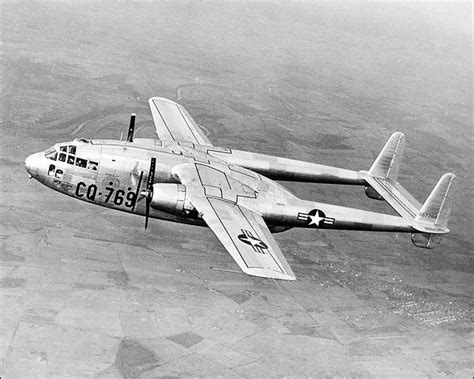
369,132,405,182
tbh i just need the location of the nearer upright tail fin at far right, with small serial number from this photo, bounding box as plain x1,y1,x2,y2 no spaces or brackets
415,174,456,233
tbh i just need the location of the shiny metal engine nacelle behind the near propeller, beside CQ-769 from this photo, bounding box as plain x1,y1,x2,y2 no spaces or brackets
150,183,195,216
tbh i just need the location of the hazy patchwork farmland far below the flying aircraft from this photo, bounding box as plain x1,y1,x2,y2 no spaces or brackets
0,3,474,378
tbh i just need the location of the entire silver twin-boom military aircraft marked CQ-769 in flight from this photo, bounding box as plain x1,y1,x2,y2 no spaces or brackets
25,97,455,280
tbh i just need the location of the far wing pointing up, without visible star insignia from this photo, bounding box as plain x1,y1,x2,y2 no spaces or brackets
148,97,212,146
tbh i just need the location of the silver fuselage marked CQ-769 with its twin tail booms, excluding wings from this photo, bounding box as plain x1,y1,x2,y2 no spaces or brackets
25,139,412,232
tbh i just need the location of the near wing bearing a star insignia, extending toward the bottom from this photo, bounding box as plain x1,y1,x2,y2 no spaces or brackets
175,164,296,280
